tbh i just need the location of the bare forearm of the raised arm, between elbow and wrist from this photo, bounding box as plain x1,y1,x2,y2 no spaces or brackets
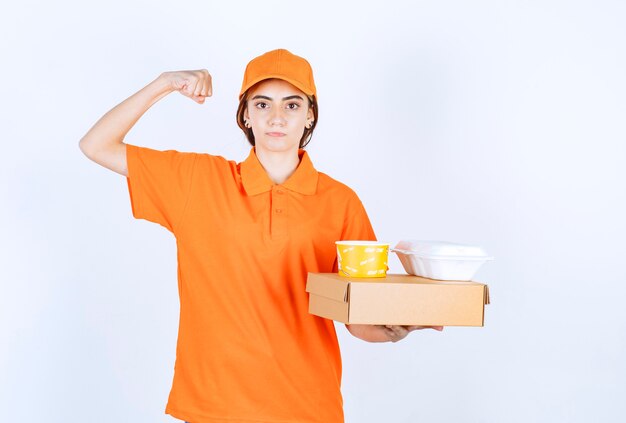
80,74,174,159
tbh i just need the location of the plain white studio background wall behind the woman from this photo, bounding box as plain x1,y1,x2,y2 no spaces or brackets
0,0,626,423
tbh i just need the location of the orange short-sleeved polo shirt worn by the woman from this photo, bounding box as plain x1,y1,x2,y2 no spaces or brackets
127,145,375,423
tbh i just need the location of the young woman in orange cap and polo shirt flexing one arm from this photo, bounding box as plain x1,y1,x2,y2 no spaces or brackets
80,50,441,423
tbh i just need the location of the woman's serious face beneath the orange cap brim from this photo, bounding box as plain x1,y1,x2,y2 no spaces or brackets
244,79,313,154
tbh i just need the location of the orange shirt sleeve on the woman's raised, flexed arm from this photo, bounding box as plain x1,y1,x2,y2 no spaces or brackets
126,144,197,232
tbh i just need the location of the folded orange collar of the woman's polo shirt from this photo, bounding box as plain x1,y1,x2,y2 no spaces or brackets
241,148,318,195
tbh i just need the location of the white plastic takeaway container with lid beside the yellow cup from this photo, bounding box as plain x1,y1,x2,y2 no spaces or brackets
391,240,493,281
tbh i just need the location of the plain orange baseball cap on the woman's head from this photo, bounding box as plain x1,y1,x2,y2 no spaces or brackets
239,49,317,100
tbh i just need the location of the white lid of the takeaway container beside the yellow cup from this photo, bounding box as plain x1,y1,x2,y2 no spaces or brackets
393,239,493,260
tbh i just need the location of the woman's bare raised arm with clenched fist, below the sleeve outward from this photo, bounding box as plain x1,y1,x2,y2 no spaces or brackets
79,69,212,176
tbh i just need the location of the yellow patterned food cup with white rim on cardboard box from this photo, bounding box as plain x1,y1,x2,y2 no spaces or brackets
335,241,389,278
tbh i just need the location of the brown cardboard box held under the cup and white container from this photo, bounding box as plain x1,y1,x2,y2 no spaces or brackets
306,273,489,326
